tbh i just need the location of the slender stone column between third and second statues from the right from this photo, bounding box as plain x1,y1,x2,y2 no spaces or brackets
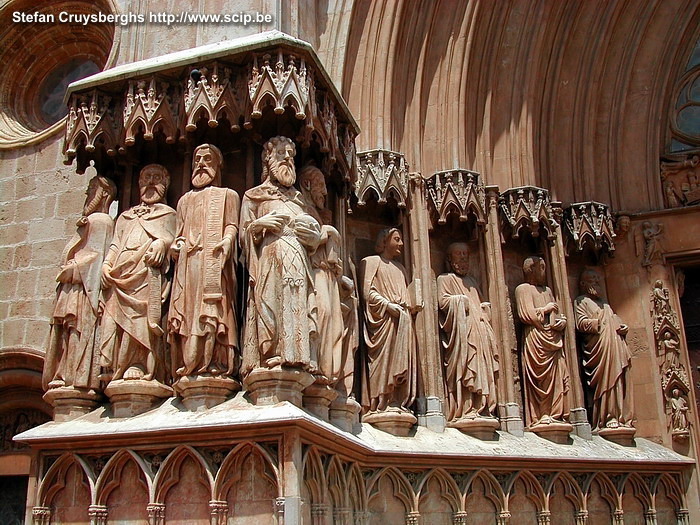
486,186,523,436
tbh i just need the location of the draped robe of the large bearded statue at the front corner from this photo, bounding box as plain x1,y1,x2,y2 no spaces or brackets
241,179,321,374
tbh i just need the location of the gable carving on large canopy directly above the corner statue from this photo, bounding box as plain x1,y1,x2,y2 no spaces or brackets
248,50,313,120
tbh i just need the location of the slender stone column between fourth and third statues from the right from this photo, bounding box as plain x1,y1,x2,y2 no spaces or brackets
408,173,445,432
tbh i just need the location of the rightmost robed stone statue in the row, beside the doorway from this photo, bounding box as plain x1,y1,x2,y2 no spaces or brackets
574,269,633,430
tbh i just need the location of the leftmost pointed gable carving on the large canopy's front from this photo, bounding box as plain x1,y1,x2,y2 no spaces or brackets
63,90,121,163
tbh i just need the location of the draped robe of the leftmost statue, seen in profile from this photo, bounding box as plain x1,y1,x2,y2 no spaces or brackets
43,212,114,389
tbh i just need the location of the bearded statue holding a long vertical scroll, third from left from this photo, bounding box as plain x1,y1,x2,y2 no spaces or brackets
168,144,239,392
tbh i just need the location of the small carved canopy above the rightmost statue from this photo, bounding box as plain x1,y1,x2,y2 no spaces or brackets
564,201,616,253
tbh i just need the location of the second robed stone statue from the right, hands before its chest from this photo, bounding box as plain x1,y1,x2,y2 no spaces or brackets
515,257,569,428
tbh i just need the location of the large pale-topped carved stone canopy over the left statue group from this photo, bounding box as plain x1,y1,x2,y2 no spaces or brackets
63,31,359,183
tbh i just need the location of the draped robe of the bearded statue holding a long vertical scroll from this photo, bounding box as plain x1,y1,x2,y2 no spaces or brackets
168,186,239,375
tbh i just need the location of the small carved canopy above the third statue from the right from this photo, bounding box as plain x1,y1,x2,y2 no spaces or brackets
426,170,486,224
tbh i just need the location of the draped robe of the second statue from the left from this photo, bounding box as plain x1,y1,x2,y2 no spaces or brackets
101,203,175,381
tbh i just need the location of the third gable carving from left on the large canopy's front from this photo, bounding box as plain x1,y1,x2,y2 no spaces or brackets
184,63,248,132
